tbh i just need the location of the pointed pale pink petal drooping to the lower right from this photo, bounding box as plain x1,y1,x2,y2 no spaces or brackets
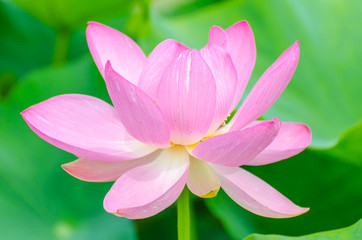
212,164,309,218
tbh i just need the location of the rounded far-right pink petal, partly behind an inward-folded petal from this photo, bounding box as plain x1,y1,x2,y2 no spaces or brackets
248,122,312,165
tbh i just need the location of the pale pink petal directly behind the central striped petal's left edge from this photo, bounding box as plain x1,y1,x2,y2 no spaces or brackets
138,39,187,99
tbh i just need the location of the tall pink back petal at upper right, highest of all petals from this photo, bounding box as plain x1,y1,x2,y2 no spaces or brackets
225,21,256,112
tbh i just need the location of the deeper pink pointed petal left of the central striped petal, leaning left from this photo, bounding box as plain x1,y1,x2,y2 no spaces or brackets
105,62,170,148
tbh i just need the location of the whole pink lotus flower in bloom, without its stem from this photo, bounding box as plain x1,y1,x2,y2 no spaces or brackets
22,21,311,219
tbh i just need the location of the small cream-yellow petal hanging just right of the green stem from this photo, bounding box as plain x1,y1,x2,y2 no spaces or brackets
187,157,220,198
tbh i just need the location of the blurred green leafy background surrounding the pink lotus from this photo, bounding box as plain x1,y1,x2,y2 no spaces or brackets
0,0,362,240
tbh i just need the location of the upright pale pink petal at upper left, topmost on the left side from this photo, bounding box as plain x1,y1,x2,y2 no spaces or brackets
86,22,146,85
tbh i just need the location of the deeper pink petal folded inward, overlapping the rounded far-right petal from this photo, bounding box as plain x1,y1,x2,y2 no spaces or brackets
192,118,280,167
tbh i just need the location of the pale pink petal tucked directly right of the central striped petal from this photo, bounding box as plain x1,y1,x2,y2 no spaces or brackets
200,44,237,133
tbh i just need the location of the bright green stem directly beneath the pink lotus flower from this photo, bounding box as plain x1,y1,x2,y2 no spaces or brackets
177,187,191,240
